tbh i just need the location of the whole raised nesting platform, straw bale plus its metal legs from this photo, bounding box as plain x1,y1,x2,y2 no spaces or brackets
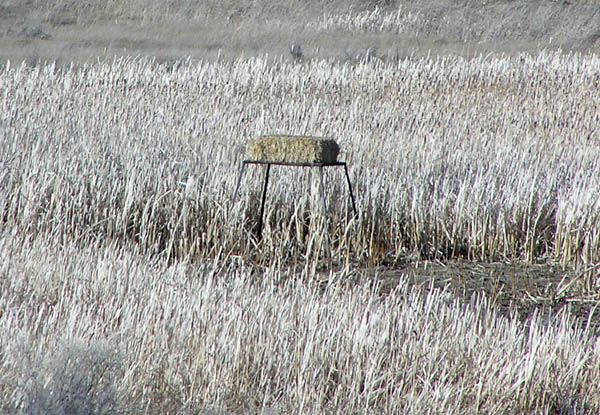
233,135,358,239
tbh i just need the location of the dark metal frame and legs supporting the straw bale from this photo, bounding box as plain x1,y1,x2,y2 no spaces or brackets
233,160,358,240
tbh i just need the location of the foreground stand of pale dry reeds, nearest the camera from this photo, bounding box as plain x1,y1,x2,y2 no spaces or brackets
0,233,600,414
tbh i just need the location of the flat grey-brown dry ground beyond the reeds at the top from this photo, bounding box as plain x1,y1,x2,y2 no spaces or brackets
0,0,600,62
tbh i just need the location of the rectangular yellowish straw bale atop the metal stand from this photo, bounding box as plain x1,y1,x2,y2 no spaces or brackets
248,135,340,163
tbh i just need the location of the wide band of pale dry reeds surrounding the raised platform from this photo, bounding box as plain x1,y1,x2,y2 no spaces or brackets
0,53,600,266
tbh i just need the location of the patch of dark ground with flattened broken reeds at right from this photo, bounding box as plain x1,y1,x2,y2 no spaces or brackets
368,260,600,335
